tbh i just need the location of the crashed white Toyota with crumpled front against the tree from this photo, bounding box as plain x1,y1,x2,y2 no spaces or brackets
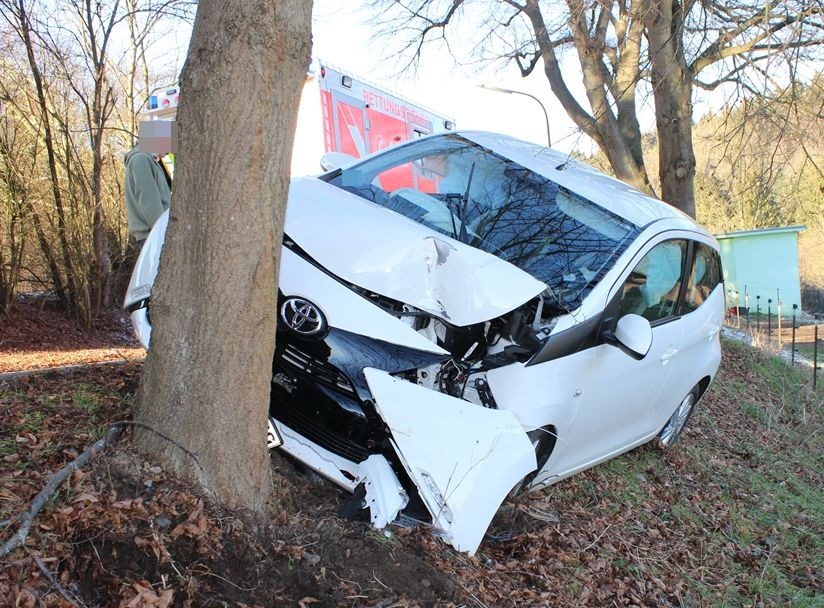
125,132,724,552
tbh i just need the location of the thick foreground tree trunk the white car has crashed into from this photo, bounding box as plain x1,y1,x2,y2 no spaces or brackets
136,0,312,512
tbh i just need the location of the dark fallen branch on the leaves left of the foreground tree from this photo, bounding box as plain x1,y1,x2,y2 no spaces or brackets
0,420,203,558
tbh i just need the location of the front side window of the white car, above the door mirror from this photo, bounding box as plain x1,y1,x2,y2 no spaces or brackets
619,240,687,321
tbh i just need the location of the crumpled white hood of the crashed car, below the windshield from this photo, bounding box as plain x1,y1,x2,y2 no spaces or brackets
286,177,546,326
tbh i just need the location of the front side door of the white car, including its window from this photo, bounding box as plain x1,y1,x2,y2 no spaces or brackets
552,239,689,476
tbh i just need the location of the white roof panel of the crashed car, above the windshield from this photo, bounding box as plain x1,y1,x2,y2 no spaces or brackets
455,131,705,232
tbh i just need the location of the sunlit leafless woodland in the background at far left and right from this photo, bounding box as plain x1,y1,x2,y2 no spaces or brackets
0,0,824,328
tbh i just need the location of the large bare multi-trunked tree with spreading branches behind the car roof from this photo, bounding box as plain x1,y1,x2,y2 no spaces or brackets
373,0,824,216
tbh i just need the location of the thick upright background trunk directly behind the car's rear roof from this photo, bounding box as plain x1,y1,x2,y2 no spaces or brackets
645,0,695,217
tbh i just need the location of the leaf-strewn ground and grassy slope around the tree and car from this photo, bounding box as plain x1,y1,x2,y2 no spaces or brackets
0,294,824,608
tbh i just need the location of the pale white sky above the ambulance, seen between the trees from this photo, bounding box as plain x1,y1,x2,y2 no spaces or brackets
148,0,768,159
